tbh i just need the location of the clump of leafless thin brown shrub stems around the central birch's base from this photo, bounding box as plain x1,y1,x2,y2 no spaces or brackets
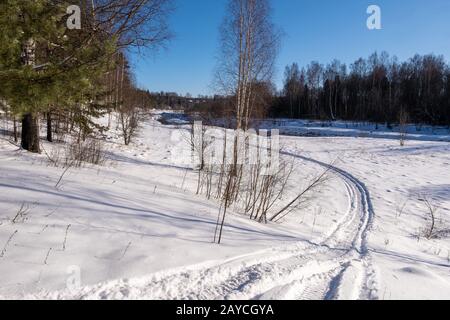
190,125,334,243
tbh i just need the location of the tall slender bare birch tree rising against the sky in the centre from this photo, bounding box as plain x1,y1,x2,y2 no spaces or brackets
214,0,280,243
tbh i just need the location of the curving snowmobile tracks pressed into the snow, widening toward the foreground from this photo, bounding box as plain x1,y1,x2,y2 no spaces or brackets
26,148,378,300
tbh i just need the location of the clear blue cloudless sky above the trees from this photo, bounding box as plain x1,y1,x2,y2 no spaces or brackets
132,0,450,96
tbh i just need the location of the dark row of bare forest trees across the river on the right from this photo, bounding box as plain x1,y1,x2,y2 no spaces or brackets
272,52,450,125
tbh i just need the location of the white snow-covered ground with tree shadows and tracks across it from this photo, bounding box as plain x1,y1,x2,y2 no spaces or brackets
0,111,450,299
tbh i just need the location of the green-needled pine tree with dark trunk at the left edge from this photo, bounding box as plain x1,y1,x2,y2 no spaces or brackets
0,0,114,152
